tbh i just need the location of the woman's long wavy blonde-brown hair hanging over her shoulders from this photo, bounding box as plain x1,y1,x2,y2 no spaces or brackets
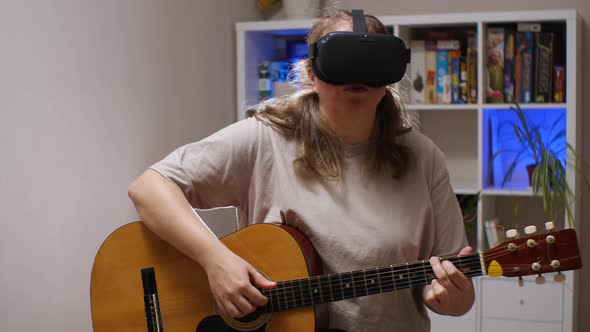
252,9,417,179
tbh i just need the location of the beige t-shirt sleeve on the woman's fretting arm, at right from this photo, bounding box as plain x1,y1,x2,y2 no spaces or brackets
430,148,467,256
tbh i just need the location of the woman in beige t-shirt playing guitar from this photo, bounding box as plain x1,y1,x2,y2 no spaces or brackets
129,11,474,331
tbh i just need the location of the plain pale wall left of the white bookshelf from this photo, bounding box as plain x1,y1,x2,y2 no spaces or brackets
0,0,261,331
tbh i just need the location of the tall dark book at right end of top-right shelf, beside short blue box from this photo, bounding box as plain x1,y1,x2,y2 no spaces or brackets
534,32,553,103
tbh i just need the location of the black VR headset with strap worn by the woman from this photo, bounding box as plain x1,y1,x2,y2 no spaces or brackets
309,9,411,87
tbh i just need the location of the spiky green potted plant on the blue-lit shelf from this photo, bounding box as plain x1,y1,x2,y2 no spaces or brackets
493,103,590,226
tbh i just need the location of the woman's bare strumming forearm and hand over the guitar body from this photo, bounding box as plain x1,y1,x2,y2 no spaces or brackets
128,170,275,317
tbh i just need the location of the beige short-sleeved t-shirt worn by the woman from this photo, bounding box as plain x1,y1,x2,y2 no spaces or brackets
152,118,467,332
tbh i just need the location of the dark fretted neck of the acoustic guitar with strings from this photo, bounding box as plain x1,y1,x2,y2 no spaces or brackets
260,253,483,313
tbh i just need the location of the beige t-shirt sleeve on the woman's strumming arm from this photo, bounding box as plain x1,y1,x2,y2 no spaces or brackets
150,118,261,209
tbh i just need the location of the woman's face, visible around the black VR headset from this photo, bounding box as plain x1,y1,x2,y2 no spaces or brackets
310,20,386,111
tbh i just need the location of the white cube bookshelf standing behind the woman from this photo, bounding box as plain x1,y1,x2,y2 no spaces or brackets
236,9,582,332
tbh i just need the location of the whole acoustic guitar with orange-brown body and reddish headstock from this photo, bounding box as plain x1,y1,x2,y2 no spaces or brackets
90,222,582,332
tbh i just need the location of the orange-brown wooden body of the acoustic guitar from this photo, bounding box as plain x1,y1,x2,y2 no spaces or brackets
90,222,319,332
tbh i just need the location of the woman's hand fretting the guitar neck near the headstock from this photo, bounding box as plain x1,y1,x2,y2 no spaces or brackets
422,247,475,316
